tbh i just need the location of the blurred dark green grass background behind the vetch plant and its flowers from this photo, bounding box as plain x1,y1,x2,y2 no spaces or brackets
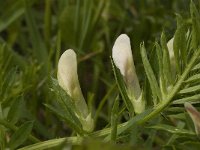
0,0,198,148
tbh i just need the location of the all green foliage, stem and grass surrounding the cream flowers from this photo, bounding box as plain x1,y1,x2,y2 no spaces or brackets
0,0,200,150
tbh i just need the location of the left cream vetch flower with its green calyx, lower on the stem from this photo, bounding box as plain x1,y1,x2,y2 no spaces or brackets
57,49,94,132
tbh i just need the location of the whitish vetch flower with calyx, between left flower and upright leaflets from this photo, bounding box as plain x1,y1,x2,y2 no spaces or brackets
112,34,145,114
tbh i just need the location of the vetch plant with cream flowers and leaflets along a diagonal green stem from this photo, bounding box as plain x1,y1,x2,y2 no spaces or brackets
0,0,200,150
